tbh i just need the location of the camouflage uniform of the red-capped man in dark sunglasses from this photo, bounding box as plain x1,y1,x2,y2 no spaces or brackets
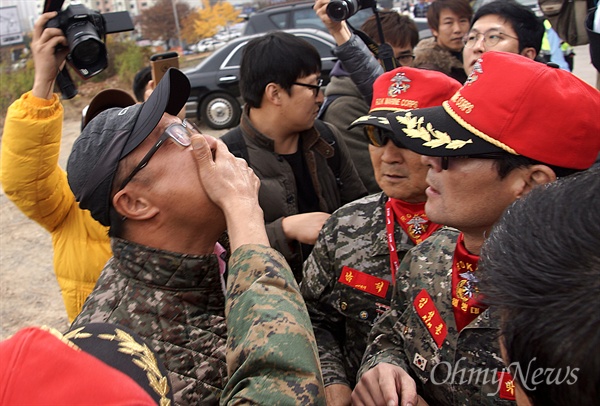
301,193,414,388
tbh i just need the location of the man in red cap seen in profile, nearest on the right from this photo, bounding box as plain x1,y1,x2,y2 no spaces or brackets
352,51,600,405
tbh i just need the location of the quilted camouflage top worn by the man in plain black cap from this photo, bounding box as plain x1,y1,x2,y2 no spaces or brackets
71,239,227,405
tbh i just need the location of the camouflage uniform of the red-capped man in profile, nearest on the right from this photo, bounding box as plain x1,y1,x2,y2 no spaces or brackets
359,227,515,406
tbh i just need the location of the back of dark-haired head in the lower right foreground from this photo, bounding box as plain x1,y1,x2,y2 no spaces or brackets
479,168,600,406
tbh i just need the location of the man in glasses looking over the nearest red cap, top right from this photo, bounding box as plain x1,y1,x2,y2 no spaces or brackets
463,0,544,75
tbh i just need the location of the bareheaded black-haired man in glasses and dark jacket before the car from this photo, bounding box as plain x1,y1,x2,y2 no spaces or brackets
222,31,366,280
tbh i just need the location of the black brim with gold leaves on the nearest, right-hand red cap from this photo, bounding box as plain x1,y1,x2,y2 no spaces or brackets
387,106,506,157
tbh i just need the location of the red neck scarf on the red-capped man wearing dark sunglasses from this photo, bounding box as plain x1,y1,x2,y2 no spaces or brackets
385,197,441,283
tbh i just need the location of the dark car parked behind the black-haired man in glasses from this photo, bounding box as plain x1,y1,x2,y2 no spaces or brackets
183,29,337,130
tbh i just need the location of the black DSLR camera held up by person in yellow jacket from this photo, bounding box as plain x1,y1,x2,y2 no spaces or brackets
46,4,133,79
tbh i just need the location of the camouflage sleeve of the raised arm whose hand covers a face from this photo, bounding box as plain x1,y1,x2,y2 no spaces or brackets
221,245,325,405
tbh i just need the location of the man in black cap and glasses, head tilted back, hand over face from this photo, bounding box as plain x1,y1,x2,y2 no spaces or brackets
67,69,324,405
